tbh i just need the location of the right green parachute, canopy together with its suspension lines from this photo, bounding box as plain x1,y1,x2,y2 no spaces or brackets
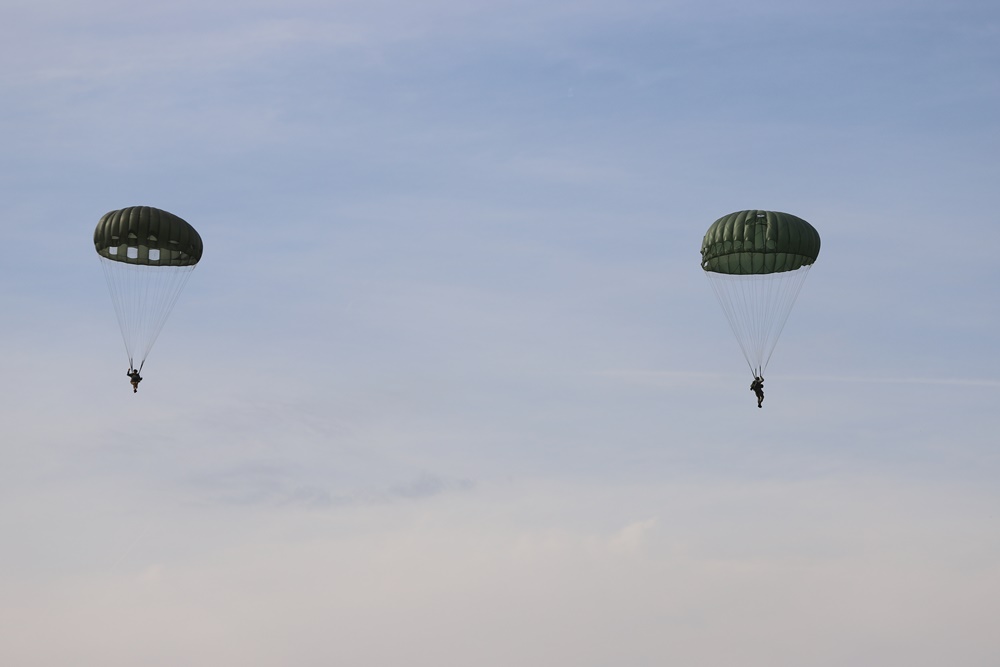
701,211,820,377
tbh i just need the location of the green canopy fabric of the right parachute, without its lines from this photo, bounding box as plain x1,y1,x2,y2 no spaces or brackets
701,211,819,275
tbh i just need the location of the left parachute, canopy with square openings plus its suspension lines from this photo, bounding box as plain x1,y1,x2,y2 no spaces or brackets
94,206,202,369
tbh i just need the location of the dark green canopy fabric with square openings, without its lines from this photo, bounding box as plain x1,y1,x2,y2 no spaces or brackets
94,206,202,266
